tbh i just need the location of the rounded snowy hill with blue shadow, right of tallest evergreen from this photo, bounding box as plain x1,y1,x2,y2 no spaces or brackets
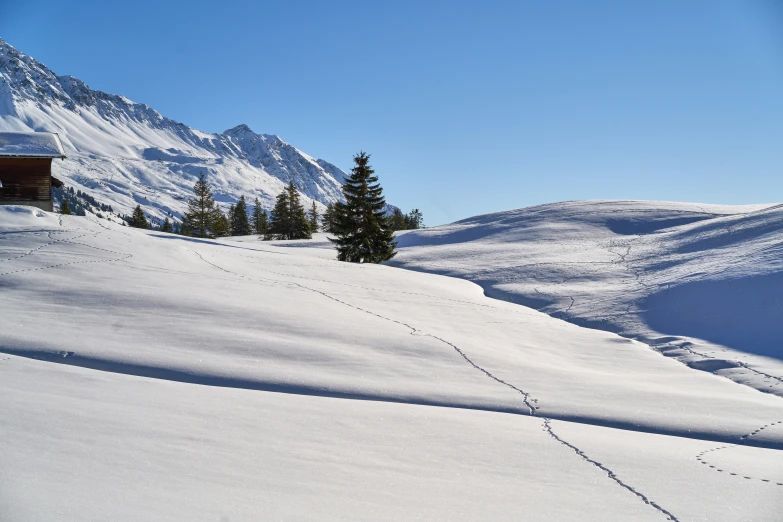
392,201,783,396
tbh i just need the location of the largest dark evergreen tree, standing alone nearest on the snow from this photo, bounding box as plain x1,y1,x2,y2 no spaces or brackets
330,152,397,263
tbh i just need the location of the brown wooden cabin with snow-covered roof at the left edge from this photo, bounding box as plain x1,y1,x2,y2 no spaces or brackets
0,132,65,212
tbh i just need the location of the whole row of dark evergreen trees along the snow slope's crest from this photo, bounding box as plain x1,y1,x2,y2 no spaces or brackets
118,152,424,263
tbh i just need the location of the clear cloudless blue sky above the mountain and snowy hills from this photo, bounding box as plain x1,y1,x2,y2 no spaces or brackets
0,0,783,225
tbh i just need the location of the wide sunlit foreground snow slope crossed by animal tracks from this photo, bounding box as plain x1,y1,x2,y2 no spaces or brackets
0,207,783,521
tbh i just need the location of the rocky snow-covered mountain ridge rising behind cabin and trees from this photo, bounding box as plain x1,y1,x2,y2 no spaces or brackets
0,40,345,218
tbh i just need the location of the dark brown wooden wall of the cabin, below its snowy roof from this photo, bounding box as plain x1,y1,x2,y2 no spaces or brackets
0,158,52,203
